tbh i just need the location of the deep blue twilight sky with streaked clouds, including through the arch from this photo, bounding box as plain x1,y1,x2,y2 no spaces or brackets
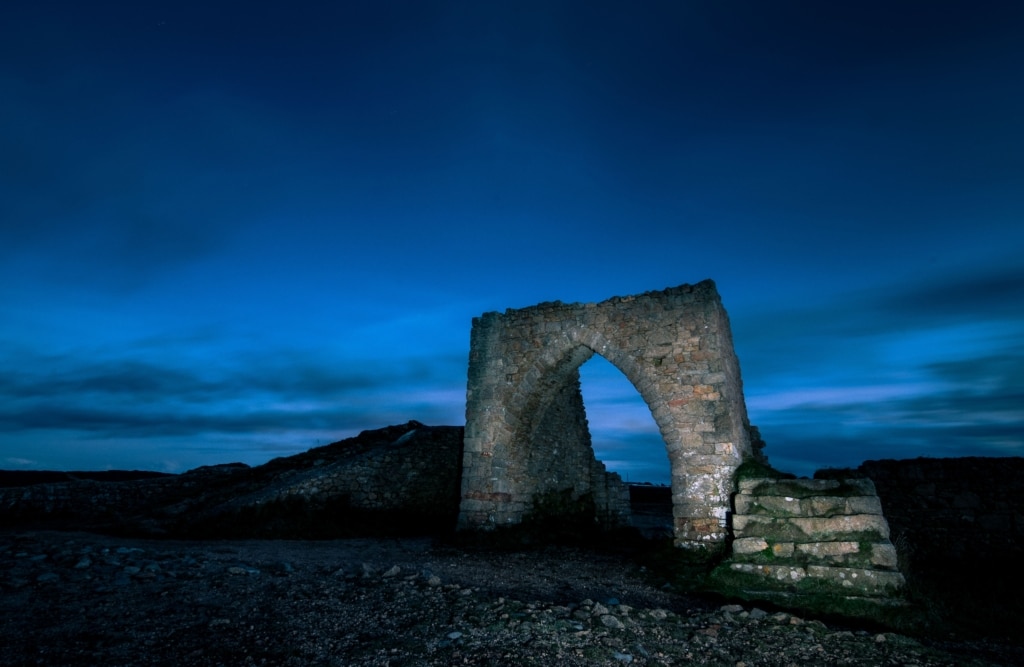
0,0,1024,482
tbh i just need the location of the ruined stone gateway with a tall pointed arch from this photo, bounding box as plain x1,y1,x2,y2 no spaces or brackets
459,281,751,548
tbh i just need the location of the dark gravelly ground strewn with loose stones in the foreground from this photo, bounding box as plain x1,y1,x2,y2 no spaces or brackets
0,531,1024,667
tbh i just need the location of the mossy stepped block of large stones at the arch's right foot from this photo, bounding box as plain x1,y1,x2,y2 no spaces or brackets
717,478,904,597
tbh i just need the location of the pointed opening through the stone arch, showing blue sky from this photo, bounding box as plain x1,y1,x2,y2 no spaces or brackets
580,355,673,538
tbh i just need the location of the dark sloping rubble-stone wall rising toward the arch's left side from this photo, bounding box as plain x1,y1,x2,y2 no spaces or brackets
0,421,463,537
